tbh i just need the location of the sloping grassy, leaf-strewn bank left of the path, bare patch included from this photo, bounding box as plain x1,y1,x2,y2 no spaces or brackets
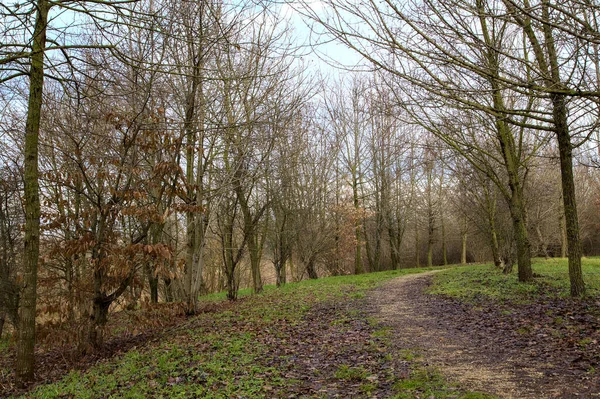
7,270,494,398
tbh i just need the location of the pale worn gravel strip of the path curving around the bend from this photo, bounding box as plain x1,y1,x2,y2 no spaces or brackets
369,271,556,399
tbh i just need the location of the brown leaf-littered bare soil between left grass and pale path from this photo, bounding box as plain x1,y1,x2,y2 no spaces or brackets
261,300,410,398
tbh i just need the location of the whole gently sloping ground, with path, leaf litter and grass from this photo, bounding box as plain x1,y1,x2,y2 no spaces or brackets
3,260,600,399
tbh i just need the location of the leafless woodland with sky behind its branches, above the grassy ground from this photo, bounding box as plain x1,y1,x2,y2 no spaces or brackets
0,0,600,397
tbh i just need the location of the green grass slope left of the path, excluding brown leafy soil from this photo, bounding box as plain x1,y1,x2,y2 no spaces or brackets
18,269,488,399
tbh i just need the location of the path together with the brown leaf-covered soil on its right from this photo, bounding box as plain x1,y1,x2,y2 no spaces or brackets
369,272,600,399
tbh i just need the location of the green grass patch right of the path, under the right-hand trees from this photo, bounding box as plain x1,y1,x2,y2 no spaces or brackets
429,258,600,303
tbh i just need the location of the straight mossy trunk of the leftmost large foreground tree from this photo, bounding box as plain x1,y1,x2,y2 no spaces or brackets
15,0,50,387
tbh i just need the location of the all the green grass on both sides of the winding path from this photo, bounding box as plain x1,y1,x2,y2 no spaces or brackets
12,258,584,399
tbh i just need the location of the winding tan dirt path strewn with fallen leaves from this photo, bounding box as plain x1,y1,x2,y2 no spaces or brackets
369,272,584,399
